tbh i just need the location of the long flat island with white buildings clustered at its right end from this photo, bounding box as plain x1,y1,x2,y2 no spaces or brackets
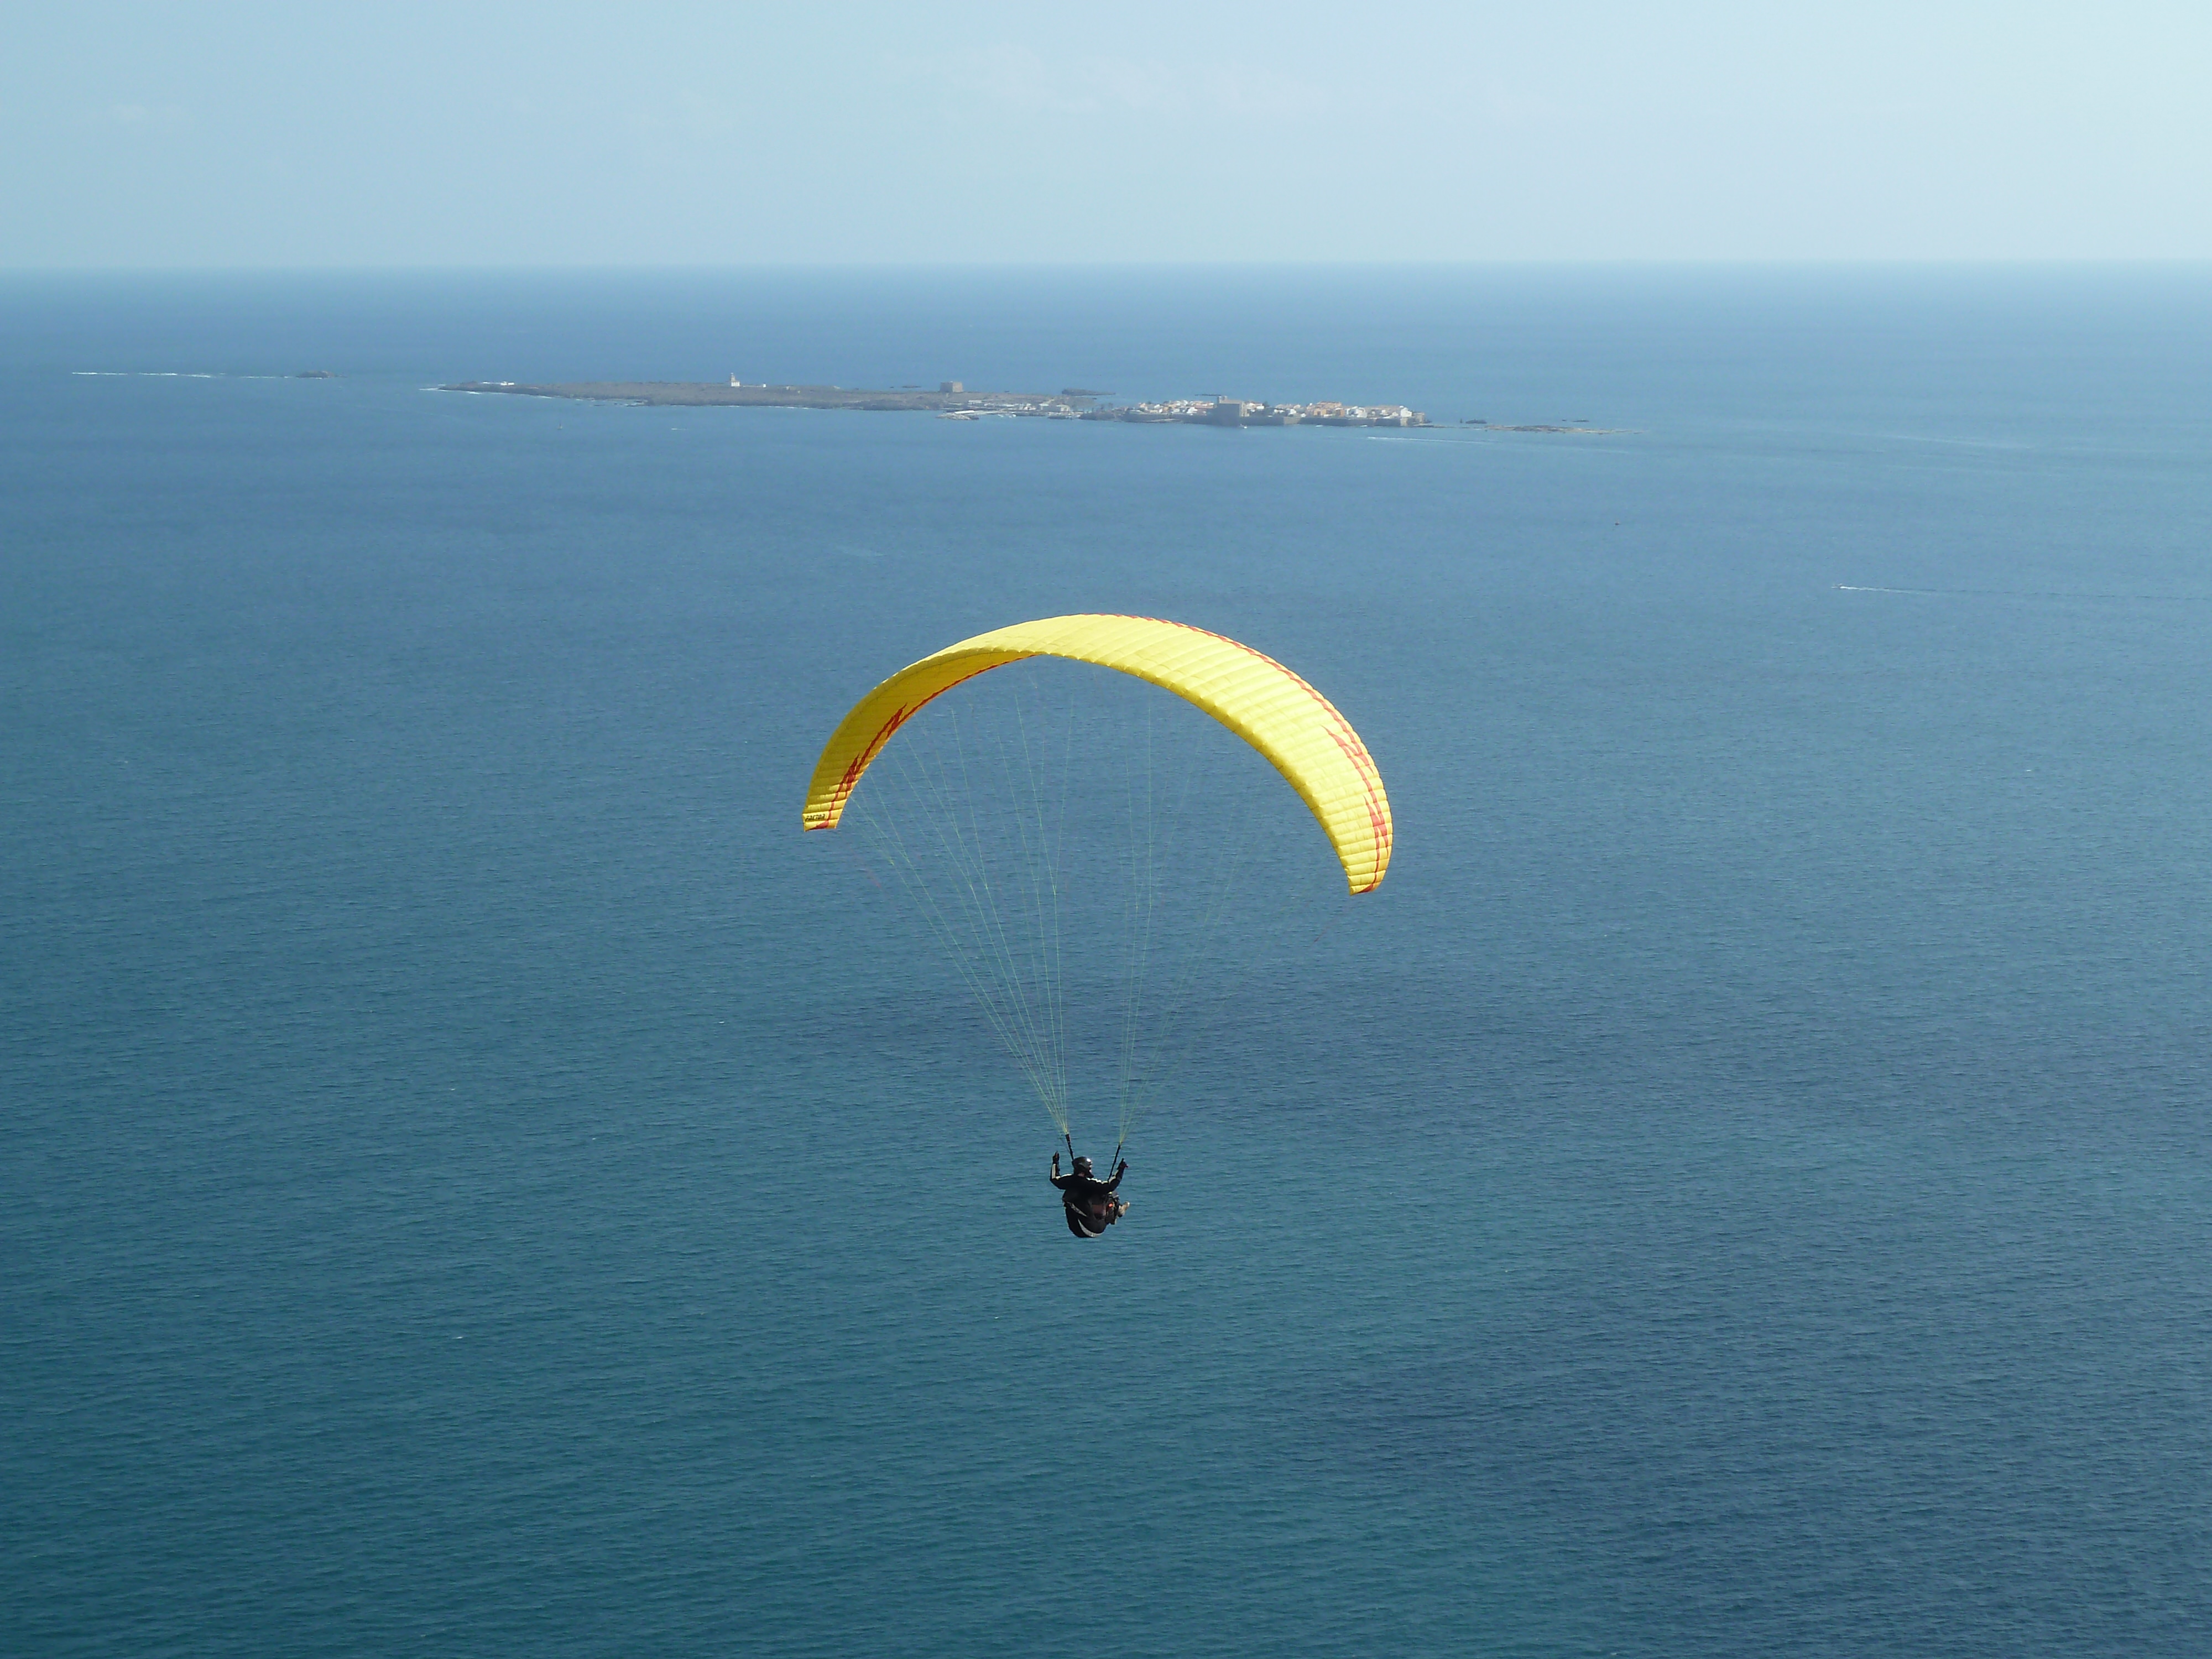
438,374,1429,427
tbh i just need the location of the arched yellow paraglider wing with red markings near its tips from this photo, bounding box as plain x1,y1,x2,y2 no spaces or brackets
803,615,1391,894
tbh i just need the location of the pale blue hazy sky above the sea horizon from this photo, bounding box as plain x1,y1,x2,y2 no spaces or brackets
0,0,2212,268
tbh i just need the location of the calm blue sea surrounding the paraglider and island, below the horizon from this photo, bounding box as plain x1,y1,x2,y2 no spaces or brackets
0,268,2212,1659
